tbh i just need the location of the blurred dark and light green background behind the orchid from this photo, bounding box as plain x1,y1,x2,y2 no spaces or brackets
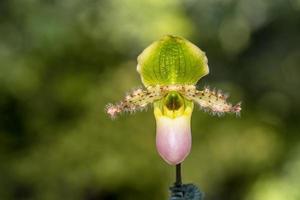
0,0,300,200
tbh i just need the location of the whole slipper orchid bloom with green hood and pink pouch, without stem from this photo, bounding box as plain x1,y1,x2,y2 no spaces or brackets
106,35,241,165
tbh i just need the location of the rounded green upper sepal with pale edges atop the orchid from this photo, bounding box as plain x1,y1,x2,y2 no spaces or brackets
137,35,209,86
